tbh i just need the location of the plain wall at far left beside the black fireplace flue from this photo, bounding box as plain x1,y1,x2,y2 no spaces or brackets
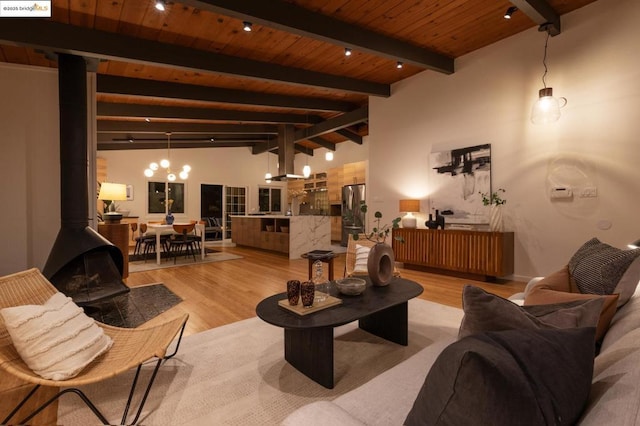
0,64,60,275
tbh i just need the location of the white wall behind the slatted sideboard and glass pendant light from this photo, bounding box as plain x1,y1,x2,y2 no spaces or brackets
369,0,640,279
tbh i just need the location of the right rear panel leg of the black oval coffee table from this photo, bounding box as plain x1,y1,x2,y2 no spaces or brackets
359,302,409,346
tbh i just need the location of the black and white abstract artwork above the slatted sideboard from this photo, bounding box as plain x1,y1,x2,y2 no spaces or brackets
429,144,491,224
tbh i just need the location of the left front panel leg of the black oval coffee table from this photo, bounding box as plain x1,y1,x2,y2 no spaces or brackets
284,327,333,389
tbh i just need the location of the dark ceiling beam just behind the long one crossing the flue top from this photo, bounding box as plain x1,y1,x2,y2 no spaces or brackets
96,75,358,112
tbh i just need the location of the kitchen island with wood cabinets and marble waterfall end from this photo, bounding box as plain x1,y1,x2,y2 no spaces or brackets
231,215,331,259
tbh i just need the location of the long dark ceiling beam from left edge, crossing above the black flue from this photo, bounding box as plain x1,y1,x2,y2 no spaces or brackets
0,18,391,97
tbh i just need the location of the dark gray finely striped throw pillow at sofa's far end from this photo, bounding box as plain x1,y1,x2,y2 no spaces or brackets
569,238,640,296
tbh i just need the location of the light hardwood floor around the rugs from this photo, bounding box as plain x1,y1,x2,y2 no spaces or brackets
0,247,525,425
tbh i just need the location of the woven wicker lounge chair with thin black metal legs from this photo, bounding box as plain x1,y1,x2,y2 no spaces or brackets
0,268,188,424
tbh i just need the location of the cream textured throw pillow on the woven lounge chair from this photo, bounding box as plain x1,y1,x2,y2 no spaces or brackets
0,293,113,380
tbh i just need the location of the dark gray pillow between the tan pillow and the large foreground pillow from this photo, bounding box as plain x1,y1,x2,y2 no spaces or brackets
458,285,604,338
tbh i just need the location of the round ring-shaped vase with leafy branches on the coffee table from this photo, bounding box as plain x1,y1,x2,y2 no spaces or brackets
352,203,404,286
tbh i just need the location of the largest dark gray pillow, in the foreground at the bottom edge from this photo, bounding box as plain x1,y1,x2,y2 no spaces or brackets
405,327,595,426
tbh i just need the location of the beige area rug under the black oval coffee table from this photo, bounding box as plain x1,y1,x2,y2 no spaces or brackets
58,299,462,426
